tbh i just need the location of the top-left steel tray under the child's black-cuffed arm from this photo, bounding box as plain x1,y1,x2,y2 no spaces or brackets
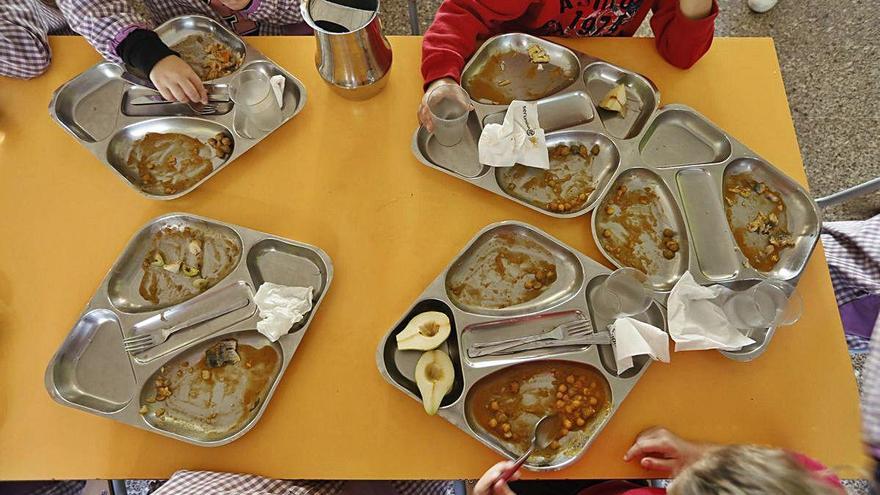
49,15,306,200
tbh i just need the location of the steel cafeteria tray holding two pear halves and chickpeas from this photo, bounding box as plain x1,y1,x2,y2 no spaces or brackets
376,221,665,471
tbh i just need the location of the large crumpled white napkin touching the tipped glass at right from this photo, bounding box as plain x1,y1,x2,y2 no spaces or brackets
666,272,755,352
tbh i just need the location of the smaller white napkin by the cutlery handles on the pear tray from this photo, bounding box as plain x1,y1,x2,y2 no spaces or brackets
608,317,669,375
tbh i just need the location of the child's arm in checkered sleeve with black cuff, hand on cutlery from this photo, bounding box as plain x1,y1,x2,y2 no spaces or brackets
57,0,208,103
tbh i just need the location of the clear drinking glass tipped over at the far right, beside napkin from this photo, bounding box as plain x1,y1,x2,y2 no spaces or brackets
722,280,804,329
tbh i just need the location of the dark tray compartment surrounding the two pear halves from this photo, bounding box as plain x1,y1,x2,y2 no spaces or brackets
382,299,464,410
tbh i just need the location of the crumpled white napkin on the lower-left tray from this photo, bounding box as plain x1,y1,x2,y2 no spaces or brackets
254,282,314,342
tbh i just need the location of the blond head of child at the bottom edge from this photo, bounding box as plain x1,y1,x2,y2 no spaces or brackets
668,445,842,495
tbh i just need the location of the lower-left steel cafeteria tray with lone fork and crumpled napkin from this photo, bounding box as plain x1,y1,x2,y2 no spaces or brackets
45,213,333,446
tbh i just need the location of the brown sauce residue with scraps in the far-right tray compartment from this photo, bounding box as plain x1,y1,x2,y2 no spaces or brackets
724,174,794,272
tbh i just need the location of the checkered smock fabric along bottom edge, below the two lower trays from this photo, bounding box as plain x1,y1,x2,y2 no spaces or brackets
153,471,453,495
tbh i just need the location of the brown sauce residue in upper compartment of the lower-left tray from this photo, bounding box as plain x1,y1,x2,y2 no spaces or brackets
138,226,241,306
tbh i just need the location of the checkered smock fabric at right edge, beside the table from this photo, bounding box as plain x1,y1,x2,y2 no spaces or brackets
822,215,880,352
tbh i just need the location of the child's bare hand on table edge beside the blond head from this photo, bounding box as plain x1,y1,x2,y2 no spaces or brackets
623,427,711,475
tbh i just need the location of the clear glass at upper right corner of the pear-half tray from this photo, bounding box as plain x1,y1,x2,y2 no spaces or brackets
592,267,653,318
